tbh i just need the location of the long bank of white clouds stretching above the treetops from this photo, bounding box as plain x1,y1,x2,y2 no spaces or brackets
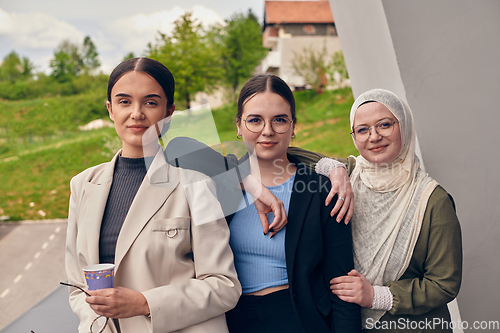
0,5,224,73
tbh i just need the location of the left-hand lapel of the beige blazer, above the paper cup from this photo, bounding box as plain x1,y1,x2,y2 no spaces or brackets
82,151,121,264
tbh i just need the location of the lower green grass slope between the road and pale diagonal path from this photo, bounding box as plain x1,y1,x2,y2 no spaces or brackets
0,128,121,220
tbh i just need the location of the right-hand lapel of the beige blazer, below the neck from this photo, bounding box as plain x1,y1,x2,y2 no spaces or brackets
115,154,179,274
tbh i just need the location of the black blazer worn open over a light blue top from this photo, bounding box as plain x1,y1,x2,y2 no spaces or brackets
166,138,361,333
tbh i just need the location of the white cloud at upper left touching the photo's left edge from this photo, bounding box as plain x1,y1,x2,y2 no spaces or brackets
0,9,84,50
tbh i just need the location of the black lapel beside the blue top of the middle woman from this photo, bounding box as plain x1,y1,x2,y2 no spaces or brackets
285,164,313,285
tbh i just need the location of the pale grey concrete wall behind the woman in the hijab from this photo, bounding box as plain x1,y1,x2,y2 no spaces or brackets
330,0,500,332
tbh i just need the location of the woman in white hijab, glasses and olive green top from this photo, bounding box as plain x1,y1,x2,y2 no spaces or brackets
324,89,462,332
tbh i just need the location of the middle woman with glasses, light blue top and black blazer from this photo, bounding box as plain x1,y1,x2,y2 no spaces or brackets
226,75,361,333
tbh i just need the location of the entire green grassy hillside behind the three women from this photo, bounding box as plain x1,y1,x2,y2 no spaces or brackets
0,88,356,220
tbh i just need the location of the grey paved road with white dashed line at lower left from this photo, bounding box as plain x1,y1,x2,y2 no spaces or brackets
0,221,67,330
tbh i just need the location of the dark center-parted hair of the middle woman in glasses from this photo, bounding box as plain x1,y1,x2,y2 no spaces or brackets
235,74,297,124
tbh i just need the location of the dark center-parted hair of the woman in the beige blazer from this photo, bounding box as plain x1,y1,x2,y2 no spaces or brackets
108,58,175,109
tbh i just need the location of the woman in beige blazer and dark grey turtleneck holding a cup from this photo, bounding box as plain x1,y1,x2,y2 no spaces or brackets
66,58,241,333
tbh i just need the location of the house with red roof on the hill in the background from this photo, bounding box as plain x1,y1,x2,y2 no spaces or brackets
262,0,341,88
